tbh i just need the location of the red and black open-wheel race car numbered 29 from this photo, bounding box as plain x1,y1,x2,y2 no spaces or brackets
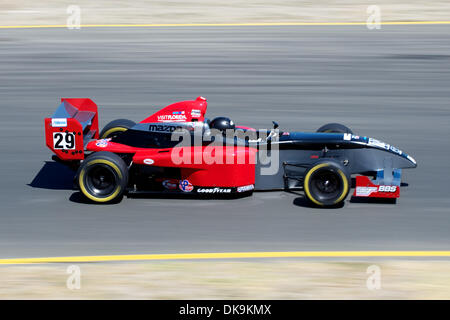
45,97,417,207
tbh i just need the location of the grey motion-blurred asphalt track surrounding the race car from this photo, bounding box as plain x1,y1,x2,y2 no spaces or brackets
0,25,450,258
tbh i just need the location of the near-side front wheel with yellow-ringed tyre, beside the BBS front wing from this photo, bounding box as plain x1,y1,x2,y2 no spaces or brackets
303,160,351,207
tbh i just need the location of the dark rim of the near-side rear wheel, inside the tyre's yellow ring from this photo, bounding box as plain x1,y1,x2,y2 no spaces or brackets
84,164,118,198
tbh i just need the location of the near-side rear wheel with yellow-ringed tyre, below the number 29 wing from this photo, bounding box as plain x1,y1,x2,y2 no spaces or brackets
76,151,128,203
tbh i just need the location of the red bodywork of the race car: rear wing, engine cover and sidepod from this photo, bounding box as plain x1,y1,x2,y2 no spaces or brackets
45,97,257,187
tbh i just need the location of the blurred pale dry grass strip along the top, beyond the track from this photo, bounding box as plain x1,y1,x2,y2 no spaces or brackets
0,0,450,25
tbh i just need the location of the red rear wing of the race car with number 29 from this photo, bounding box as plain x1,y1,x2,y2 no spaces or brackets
45,98,99,160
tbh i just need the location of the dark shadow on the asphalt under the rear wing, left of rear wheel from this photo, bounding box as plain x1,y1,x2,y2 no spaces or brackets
28,161,76,190
